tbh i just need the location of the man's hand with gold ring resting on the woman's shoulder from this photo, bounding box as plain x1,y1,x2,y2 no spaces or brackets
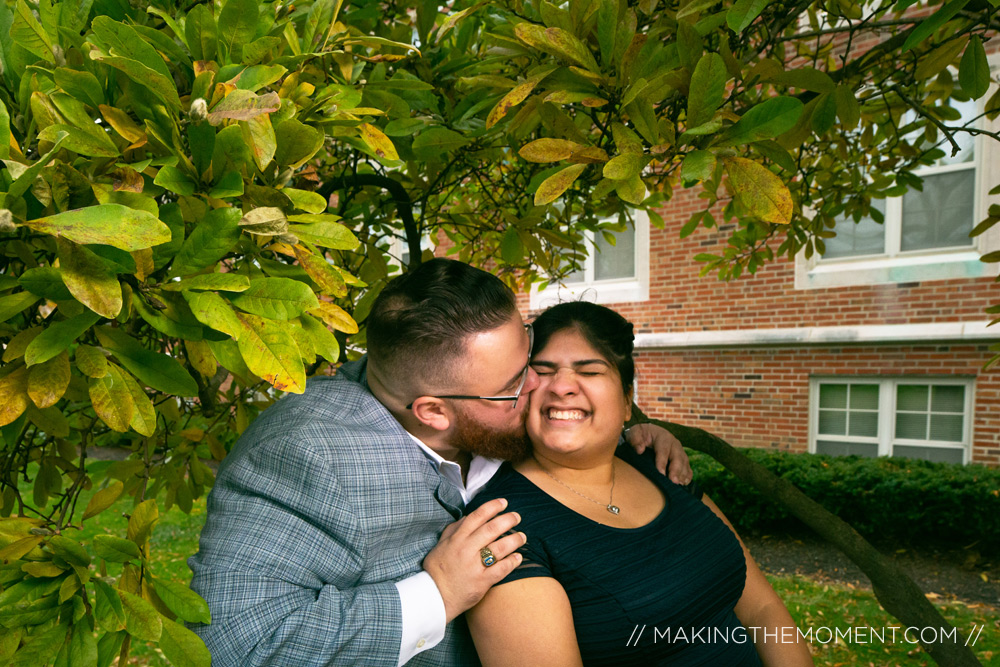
424,498,527,623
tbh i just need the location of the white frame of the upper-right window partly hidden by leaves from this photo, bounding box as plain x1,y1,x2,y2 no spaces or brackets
795,54,1000,289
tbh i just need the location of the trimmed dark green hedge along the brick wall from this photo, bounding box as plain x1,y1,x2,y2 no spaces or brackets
691,449,1000,550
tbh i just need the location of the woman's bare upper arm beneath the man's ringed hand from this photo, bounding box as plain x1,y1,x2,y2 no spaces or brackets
465,577,583,667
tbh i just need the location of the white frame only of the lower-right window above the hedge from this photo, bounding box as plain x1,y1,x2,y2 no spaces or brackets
809,375,975,465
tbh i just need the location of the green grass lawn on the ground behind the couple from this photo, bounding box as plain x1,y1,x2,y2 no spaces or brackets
15,470,1000,667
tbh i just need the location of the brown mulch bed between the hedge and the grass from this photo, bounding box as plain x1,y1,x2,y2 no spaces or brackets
744,535,1000,607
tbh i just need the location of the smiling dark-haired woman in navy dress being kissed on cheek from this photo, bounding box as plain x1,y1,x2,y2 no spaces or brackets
467,302,812,667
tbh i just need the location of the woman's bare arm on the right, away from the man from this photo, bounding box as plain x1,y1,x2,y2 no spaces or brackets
702,496,813,667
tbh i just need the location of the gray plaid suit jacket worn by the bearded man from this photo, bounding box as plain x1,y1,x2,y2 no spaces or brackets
188,359,478,667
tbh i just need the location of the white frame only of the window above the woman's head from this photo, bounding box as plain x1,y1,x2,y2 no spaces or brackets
529,211,649,310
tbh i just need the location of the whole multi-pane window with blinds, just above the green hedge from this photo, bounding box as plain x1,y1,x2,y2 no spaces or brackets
809,378,972,463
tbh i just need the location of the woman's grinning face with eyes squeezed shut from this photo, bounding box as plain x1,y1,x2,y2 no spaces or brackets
527,329,632,456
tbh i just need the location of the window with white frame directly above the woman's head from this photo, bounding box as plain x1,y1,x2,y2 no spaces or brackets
531,211,649,310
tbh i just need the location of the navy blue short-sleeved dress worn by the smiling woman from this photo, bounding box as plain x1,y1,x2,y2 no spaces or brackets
468,447,761,667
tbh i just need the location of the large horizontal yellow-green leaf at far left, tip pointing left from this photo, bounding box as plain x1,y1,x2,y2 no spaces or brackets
24,204,170,252
